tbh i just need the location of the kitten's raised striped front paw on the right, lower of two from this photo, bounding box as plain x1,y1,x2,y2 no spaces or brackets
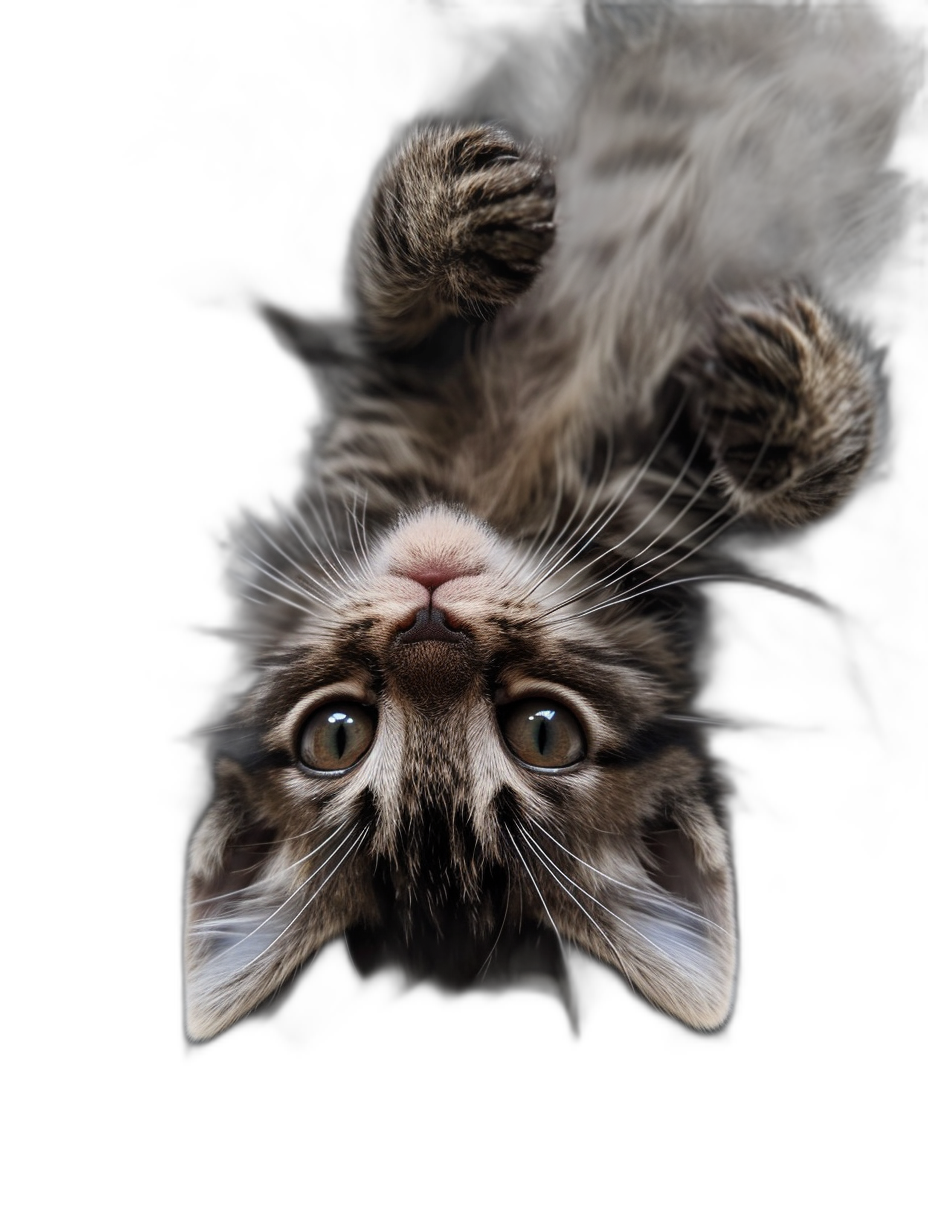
686,286,882,526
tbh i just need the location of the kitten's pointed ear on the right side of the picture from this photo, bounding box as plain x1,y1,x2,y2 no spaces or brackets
589,803,738,1030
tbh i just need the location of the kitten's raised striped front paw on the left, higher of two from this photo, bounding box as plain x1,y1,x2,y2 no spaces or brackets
350,126,555,349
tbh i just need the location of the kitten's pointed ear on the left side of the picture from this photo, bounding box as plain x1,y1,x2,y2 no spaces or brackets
184,760,339,1040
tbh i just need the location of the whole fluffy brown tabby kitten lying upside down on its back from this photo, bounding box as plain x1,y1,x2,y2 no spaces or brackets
186,6,910,1039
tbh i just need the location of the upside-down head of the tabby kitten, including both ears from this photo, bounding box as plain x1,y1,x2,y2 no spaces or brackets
187,504,735,1039
